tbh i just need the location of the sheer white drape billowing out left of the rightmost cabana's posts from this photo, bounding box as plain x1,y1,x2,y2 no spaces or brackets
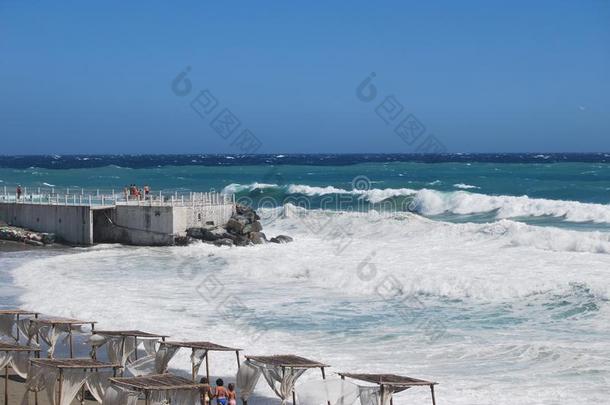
296,379,360,405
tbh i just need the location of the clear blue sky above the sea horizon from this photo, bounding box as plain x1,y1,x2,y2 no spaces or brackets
0,0,610,154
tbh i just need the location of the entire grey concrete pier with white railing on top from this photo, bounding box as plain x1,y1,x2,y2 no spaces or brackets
0,193,235,246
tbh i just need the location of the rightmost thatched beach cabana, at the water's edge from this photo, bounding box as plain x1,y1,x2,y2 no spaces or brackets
338,373,438,405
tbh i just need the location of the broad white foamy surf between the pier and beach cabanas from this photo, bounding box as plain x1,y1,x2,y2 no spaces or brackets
8,206,610,405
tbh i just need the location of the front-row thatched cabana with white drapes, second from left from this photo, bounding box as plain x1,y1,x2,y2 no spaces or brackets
21,358,120,405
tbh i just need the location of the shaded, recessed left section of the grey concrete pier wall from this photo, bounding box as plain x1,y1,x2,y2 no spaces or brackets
0,203,93,245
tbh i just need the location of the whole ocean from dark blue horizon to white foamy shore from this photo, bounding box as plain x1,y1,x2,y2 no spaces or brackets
0,154,610,405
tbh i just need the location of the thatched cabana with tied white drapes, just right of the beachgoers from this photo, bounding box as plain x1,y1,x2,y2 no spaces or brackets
237,354,329,405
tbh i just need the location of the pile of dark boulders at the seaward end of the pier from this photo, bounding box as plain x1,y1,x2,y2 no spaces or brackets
183,204,292,246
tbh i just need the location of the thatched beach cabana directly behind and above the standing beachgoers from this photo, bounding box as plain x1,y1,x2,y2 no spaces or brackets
157,341,241,381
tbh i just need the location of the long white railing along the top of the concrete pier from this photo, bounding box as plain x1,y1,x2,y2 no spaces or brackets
0,187,235,207
